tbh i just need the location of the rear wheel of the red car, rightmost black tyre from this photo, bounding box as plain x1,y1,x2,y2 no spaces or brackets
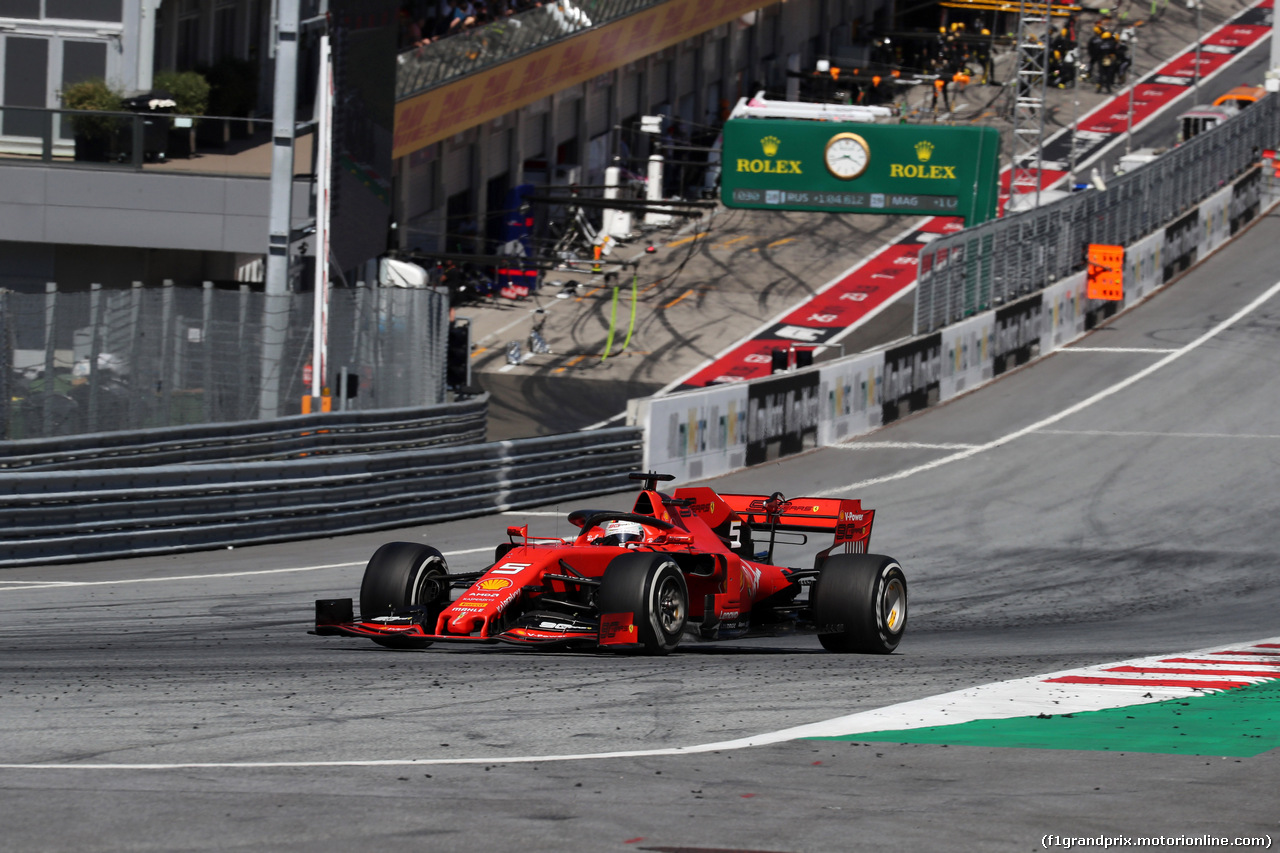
810,553,906,654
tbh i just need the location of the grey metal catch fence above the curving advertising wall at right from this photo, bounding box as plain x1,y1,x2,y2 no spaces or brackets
915,95,1280,334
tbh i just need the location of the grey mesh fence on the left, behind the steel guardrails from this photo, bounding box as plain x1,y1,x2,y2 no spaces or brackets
0,282,448,441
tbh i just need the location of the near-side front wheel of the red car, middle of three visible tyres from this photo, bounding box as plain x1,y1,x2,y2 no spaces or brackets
595,553,689,654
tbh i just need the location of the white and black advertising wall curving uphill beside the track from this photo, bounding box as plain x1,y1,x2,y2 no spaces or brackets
627,142,1275,482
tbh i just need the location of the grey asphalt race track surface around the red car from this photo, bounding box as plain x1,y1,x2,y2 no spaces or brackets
0,215,1280,852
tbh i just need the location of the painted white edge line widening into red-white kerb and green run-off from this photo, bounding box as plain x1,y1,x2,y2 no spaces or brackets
0,638,1280,772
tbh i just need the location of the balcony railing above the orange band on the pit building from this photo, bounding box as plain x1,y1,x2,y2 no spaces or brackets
396,0,664,100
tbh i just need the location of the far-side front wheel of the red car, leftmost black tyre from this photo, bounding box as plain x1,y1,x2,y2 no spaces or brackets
360,542,449,648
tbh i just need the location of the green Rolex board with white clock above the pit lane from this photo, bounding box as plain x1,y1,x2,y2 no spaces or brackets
721,118,1000,225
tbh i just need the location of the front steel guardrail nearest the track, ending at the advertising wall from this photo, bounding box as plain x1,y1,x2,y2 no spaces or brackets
0,427,643,567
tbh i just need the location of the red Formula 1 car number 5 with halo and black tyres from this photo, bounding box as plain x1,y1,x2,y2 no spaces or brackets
315,474,906,654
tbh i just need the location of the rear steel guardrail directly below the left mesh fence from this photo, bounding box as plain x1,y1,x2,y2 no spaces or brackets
0,394,489,468
